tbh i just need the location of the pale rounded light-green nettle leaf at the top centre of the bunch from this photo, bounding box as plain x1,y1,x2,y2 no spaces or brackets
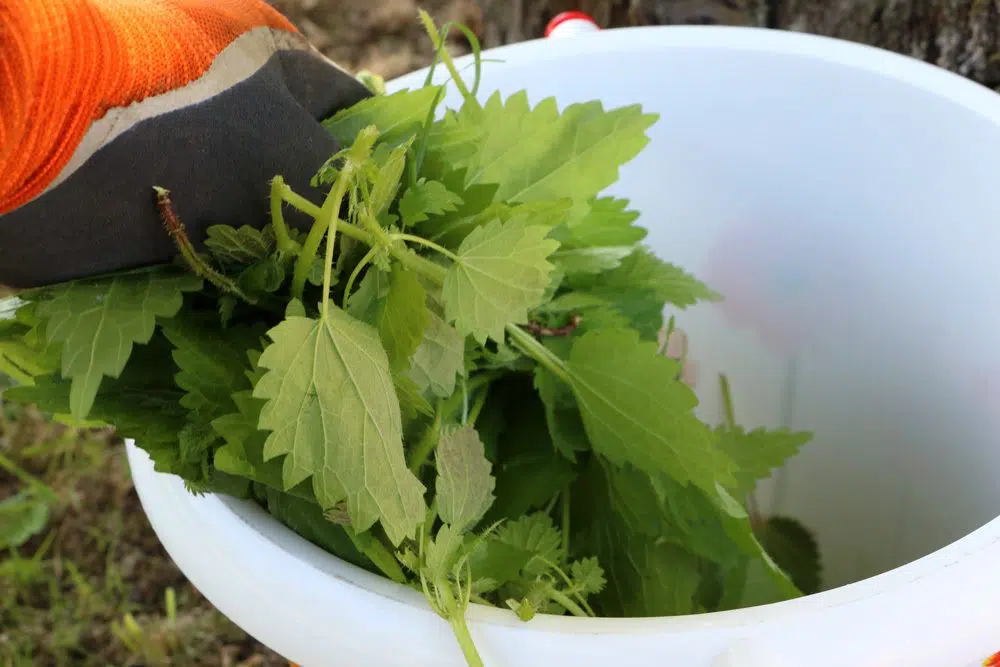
442,222,559,344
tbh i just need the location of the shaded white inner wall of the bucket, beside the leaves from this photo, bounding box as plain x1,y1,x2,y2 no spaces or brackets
418,30,1000,588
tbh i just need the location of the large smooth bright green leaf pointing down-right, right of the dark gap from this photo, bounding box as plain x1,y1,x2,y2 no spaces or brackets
569,329,733,492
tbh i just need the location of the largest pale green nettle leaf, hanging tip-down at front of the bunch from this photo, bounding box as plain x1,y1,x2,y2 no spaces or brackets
254,308,425,545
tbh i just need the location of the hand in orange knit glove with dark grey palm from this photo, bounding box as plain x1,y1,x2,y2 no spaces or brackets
0,0,369,287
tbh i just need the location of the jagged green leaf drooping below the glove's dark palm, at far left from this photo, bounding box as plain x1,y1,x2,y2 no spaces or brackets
38,271,202,419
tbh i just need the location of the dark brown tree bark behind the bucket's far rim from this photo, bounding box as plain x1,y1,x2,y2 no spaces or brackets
478,0,1000,88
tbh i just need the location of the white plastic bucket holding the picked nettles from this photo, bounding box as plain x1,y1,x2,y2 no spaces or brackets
129,27,1000,667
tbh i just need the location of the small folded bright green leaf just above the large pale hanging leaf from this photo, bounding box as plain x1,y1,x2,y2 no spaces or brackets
375,264,430,372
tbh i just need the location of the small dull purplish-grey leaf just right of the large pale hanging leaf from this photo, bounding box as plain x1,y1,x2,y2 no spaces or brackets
435,425,496,532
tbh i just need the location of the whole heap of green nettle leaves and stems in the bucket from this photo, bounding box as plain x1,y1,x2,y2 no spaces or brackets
0,15,819,665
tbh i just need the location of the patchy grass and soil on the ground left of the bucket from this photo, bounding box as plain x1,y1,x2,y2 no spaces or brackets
0,386,288,667
